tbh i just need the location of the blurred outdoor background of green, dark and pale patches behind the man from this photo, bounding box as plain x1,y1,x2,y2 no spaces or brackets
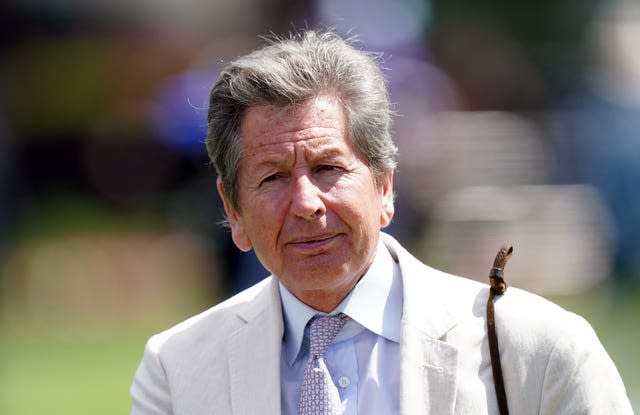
0,0,640,415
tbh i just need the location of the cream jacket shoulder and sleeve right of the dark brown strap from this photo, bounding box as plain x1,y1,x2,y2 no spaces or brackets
496,288,633,414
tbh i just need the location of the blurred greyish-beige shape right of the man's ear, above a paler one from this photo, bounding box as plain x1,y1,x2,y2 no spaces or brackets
397,112,547,209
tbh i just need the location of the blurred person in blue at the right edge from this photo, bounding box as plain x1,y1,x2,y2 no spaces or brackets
552,0,640,282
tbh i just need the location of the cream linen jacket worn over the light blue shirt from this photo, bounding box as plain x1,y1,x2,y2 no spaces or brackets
131,234,633,415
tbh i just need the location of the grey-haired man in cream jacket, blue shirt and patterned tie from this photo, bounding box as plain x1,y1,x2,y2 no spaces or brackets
131,31,632,415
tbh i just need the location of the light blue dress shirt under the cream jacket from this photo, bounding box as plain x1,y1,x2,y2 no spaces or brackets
280,243,402,415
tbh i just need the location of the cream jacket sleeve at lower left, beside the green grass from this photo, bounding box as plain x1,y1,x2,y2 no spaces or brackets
130,337,173,415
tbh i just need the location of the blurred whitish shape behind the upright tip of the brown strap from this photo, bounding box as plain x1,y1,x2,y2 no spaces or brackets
420,185,610,294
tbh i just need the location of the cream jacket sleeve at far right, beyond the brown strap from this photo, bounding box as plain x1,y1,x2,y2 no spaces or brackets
540,315,633,415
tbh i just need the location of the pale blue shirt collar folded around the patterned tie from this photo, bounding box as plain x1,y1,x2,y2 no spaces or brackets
279,242,402,365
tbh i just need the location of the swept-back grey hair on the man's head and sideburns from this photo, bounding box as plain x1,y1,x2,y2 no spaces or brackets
206,31,397,211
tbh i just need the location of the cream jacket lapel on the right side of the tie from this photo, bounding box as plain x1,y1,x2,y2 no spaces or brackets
383,234,458,415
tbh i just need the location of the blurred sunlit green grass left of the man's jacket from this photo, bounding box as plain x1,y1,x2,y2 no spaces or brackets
0,310,205,415
